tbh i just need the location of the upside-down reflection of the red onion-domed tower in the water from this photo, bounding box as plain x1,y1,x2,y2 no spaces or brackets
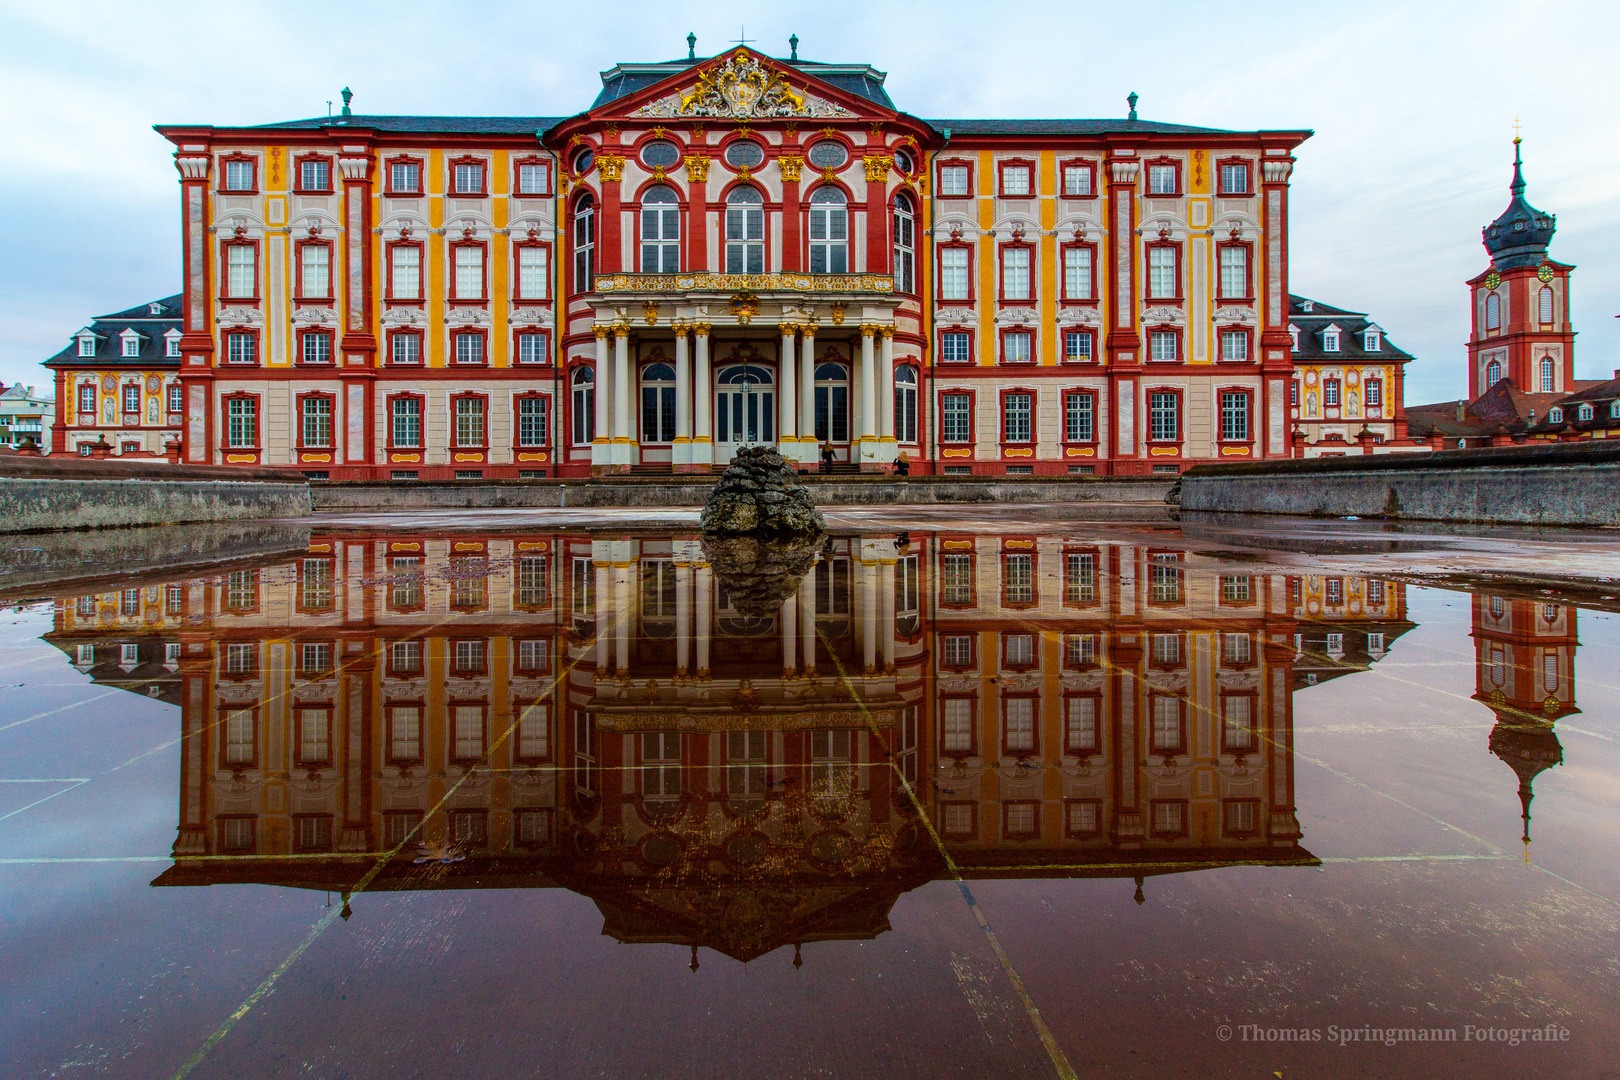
1473,594,1580,844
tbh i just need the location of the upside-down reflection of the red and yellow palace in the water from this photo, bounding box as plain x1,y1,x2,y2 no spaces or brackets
52,531,1432,959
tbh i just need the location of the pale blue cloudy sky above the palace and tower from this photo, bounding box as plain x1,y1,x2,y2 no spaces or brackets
0,0,1620,403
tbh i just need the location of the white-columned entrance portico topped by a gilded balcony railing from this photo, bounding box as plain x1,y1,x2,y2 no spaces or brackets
591,274,897,474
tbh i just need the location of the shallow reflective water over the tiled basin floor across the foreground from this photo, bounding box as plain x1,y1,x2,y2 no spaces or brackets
0,512,1620,1080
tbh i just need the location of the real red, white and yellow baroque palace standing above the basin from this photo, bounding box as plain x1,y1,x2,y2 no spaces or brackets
91,39,1328,479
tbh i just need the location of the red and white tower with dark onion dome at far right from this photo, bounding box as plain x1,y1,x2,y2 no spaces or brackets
1468,138,1575,400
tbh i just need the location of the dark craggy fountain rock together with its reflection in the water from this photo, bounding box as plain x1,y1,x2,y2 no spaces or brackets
701,447,826,619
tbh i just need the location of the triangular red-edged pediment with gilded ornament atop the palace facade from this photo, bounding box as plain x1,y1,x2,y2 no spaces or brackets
591,47,894,123
